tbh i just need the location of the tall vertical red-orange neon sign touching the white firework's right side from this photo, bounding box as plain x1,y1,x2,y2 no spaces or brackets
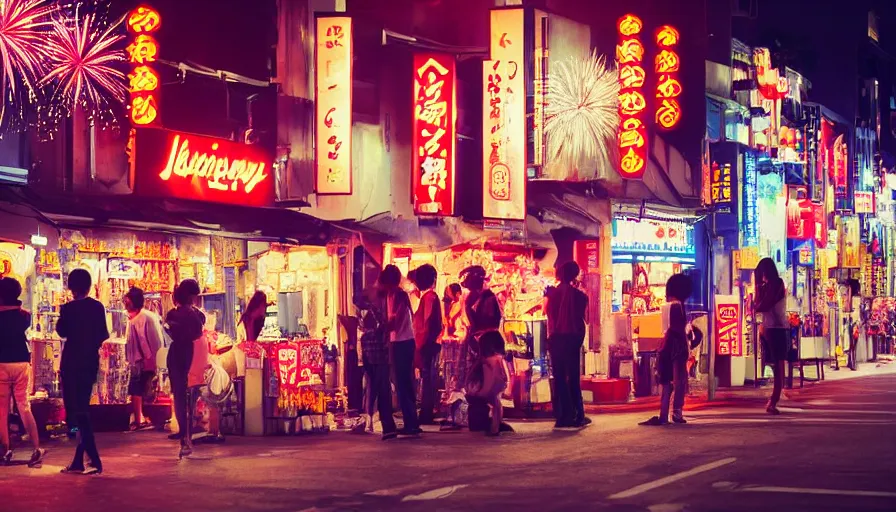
616,14,647,179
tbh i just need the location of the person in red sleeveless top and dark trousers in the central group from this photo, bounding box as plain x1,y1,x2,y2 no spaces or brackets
414,264,442,425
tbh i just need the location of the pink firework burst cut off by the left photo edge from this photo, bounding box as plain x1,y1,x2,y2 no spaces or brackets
0,0,54,127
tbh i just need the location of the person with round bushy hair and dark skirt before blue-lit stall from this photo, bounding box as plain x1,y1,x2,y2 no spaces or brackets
640,274,702,426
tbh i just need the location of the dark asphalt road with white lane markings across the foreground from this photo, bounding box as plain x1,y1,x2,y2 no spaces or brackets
0,373,896,512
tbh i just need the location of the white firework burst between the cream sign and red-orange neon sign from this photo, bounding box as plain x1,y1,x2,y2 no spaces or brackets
544,51,619,171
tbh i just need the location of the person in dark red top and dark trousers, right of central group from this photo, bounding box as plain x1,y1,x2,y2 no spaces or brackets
545,261,591,429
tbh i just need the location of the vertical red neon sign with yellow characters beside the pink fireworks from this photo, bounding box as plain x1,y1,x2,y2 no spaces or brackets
126,6,162,126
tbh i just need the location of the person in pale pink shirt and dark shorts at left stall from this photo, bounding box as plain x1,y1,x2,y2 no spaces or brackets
124,287,164,430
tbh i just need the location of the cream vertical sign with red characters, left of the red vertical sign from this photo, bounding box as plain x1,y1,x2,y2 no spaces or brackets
314,16,352,195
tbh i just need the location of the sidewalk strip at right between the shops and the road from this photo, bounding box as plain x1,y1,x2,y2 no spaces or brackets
585,356,896,414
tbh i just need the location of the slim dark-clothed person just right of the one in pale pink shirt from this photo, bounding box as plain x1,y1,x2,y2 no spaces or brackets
165,279,205,457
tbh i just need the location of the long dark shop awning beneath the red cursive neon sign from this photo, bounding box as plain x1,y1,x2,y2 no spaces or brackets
0,187,331,245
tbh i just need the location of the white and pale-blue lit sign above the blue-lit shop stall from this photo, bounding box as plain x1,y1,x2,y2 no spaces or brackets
610,218,696,261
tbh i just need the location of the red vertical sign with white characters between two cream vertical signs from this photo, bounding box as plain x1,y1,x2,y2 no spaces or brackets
411,53,457,215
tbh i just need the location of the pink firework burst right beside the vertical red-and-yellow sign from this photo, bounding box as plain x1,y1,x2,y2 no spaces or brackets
40,10,127,114
